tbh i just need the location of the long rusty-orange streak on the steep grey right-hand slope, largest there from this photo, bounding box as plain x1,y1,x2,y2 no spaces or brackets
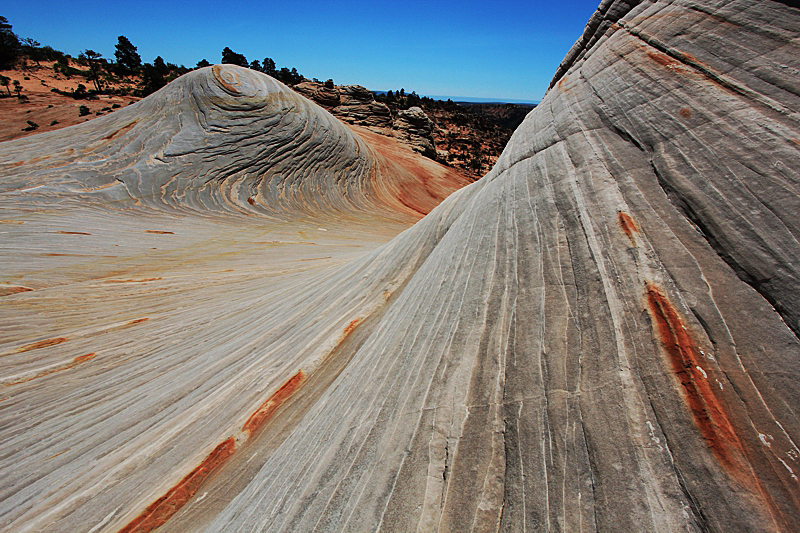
647,283,744,470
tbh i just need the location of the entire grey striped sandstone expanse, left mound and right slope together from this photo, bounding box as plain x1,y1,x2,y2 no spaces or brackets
0,0,800,532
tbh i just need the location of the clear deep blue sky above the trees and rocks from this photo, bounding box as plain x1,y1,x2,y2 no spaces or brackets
0,0,600,101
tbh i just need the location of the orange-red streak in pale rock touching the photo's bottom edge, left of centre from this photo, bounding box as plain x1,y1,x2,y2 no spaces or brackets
119,437,236,533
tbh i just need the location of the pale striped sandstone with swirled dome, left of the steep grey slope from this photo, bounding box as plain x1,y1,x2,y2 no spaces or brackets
0,65,468,532
